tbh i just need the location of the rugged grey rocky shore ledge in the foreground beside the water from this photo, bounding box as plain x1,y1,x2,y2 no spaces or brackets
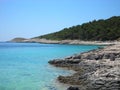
49,44,120,90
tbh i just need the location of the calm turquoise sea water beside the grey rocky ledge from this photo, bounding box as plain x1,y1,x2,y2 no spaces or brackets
0,43,98,90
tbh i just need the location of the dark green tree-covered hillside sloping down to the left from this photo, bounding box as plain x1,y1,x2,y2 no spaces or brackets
35,16,120,41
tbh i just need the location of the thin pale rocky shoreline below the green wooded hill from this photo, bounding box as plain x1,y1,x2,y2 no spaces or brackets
8,39,118,45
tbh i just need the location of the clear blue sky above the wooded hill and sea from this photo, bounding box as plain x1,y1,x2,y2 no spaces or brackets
0,0,120,41
